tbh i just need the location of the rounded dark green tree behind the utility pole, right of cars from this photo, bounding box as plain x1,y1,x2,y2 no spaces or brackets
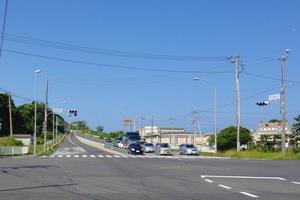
209,126,252,151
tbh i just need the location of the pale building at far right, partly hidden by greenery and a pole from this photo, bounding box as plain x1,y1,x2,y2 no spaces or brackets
253,122,292,147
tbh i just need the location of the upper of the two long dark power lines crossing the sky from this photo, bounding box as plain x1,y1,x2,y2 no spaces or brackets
5,34,228,62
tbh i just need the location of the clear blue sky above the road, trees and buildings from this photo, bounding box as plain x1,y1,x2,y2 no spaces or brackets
0,0,300,132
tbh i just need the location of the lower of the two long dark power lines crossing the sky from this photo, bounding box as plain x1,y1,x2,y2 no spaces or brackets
3,49,232,74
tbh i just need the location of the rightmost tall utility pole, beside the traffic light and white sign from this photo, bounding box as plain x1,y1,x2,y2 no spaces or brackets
280,49,289,154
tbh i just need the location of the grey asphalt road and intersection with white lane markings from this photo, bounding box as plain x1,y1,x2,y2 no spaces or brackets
0,136,300,200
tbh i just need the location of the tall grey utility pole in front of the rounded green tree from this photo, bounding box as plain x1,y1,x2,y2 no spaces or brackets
231,56,241,151
